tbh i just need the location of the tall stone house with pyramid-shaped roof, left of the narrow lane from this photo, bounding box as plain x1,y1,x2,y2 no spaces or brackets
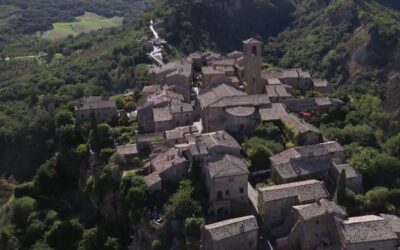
203,154,249,218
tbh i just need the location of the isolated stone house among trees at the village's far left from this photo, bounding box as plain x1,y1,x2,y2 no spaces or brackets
75,96,118,123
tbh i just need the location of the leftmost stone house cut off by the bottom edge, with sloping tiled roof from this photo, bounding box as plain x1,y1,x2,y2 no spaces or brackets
201,215,258,250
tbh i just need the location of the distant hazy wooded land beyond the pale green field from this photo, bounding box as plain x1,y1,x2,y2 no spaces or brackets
0,0,156,56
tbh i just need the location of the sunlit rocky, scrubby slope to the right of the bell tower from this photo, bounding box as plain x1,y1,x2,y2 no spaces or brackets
267,0,400,98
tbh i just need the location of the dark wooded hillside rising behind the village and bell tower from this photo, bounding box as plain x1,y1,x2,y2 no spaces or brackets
155,0,400,111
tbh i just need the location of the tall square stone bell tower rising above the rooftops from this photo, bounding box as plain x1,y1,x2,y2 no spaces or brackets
242,38,265,95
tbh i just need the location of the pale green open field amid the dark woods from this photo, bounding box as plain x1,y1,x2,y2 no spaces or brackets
42,12,123,41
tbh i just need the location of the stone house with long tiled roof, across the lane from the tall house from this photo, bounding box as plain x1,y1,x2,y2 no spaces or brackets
257,180,330,228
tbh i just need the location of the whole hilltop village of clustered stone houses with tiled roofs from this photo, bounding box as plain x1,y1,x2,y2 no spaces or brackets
75,38,400,250
